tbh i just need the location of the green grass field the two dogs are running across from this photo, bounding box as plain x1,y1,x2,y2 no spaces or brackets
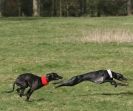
0,17,133,111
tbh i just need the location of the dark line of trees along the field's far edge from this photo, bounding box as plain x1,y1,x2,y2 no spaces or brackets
0,0,133,17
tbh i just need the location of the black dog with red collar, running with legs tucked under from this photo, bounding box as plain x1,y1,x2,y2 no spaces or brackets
7,73,63,101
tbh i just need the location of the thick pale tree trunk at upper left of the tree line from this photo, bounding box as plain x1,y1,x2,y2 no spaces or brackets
33,0,40,16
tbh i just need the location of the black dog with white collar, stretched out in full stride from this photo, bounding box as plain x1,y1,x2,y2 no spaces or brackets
54,70,127,88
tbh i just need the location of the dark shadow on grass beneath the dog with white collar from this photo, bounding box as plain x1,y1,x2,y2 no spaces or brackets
79,91,133,96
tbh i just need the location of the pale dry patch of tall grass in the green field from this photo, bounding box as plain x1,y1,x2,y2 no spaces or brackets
79,29,133,43
